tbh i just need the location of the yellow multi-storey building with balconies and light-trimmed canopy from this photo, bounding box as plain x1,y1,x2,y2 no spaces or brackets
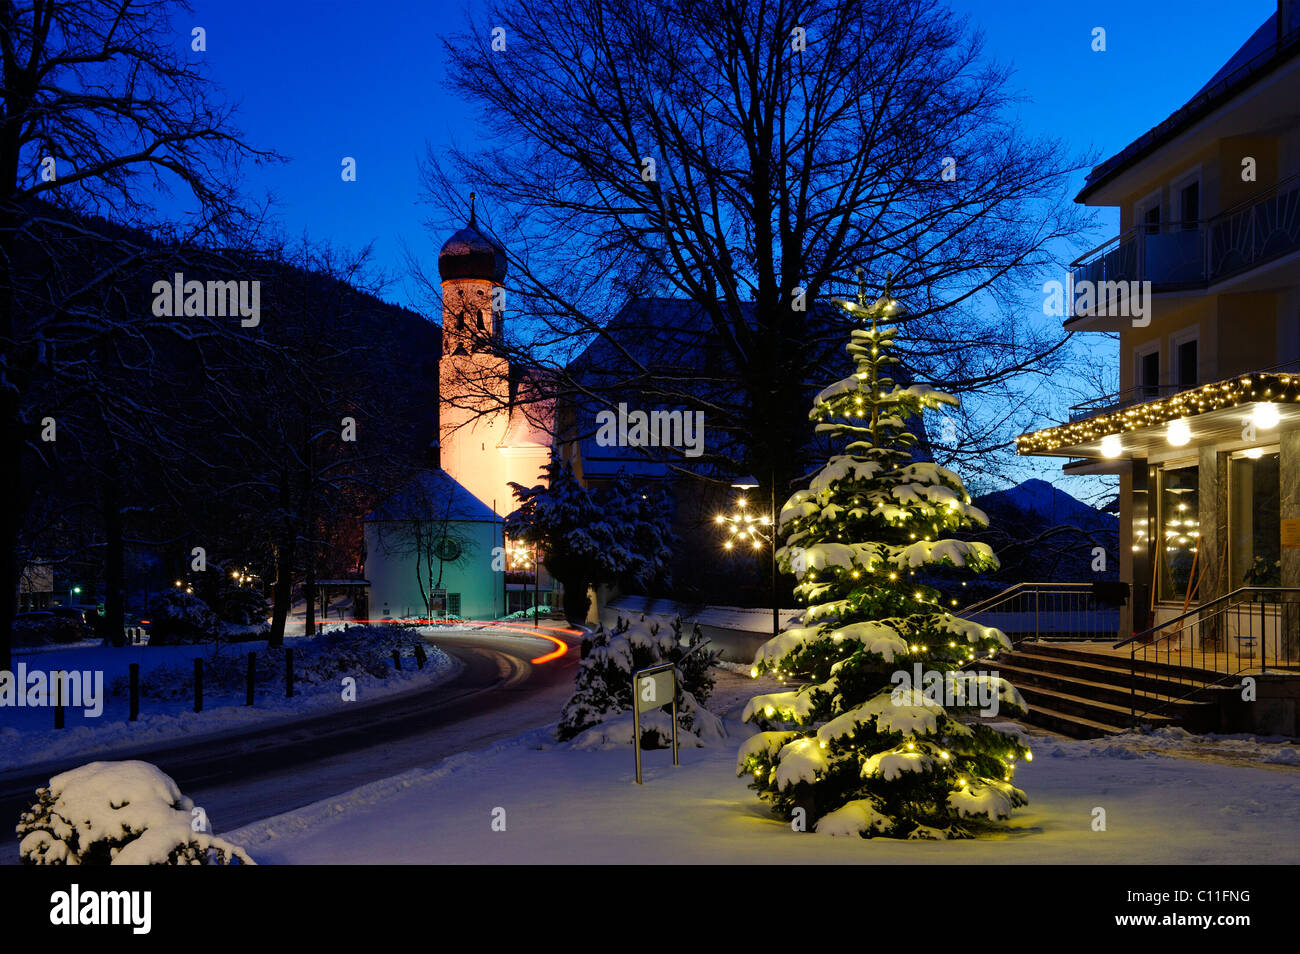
1018,0,1300,649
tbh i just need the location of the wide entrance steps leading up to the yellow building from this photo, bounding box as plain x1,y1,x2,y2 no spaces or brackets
978,641,1234,738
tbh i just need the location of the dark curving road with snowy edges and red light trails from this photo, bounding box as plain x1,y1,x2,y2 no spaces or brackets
0,632,577,863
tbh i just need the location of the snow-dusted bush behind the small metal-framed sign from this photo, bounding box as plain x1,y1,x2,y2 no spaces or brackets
556,617,725,749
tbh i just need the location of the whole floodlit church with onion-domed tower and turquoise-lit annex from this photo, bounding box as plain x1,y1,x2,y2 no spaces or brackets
365,207,555,619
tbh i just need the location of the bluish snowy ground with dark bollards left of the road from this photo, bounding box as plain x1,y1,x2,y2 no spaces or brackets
0,626,460,771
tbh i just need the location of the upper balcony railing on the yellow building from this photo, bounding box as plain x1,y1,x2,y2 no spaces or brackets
1070,175,1300,317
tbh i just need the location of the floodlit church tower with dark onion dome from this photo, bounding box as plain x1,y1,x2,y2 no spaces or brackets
438,194,515,515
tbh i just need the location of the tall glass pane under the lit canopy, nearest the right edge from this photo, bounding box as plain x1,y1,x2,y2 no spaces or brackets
1229,450,1282,590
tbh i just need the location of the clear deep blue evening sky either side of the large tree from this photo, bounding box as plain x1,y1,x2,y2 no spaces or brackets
185,0,1275,304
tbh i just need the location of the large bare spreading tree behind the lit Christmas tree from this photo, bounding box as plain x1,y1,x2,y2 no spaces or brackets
423,0,1084,527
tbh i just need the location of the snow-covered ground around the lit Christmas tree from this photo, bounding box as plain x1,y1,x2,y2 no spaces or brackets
225,667,1300,866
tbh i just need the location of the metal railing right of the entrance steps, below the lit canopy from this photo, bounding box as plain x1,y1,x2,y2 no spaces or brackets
1114,586,1300,727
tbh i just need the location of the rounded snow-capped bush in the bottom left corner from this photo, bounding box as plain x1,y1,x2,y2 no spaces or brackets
17,762,255,864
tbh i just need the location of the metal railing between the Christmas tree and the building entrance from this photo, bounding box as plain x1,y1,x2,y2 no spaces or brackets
957,582,1126,645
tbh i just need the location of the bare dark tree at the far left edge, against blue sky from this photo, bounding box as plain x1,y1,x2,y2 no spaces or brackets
0,0,274,668
